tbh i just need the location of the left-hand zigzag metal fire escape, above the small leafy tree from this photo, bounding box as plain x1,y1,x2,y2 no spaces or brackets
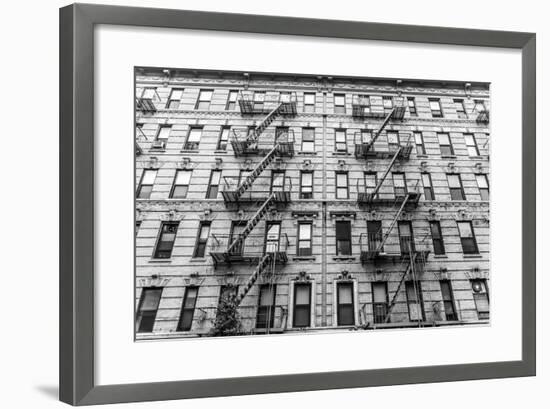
210,92,296,305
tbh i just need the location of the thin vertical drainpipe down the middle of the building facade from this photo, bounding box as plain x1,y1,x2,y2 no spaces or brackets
321,90,327,327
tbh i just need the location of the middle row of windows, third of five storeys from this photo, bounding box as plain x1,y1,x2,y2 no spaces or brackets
136,169,489,201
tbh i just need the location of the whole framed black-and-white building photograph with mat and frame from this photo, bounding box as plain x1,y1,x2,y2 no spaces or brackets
60,4,535,405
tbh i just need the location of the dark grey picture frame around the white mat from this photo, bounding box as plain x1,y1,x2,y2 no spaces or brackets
59,4,536,405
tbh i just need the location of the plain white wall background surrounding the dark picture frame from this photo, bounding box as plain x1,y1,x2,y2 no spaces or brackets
0,0,550,409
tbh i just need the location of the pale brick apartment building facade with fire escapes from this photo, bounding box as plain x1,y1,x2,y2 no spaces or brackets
135,69,490,340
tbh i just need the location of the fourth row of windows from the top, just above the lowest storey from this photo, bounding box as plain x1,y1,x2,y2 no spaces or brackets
136,220,479,259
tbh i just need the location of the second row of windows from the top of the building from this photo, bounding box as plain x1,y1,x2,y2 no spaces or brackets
137,124,490,157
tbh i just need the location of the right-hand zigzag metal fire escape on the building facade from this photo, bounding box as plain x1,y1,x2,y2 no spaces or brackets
353,96,429,323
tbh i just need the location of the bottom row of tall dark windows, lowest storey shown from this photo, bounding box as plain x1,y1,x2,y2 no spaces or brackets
136,279,489,333
